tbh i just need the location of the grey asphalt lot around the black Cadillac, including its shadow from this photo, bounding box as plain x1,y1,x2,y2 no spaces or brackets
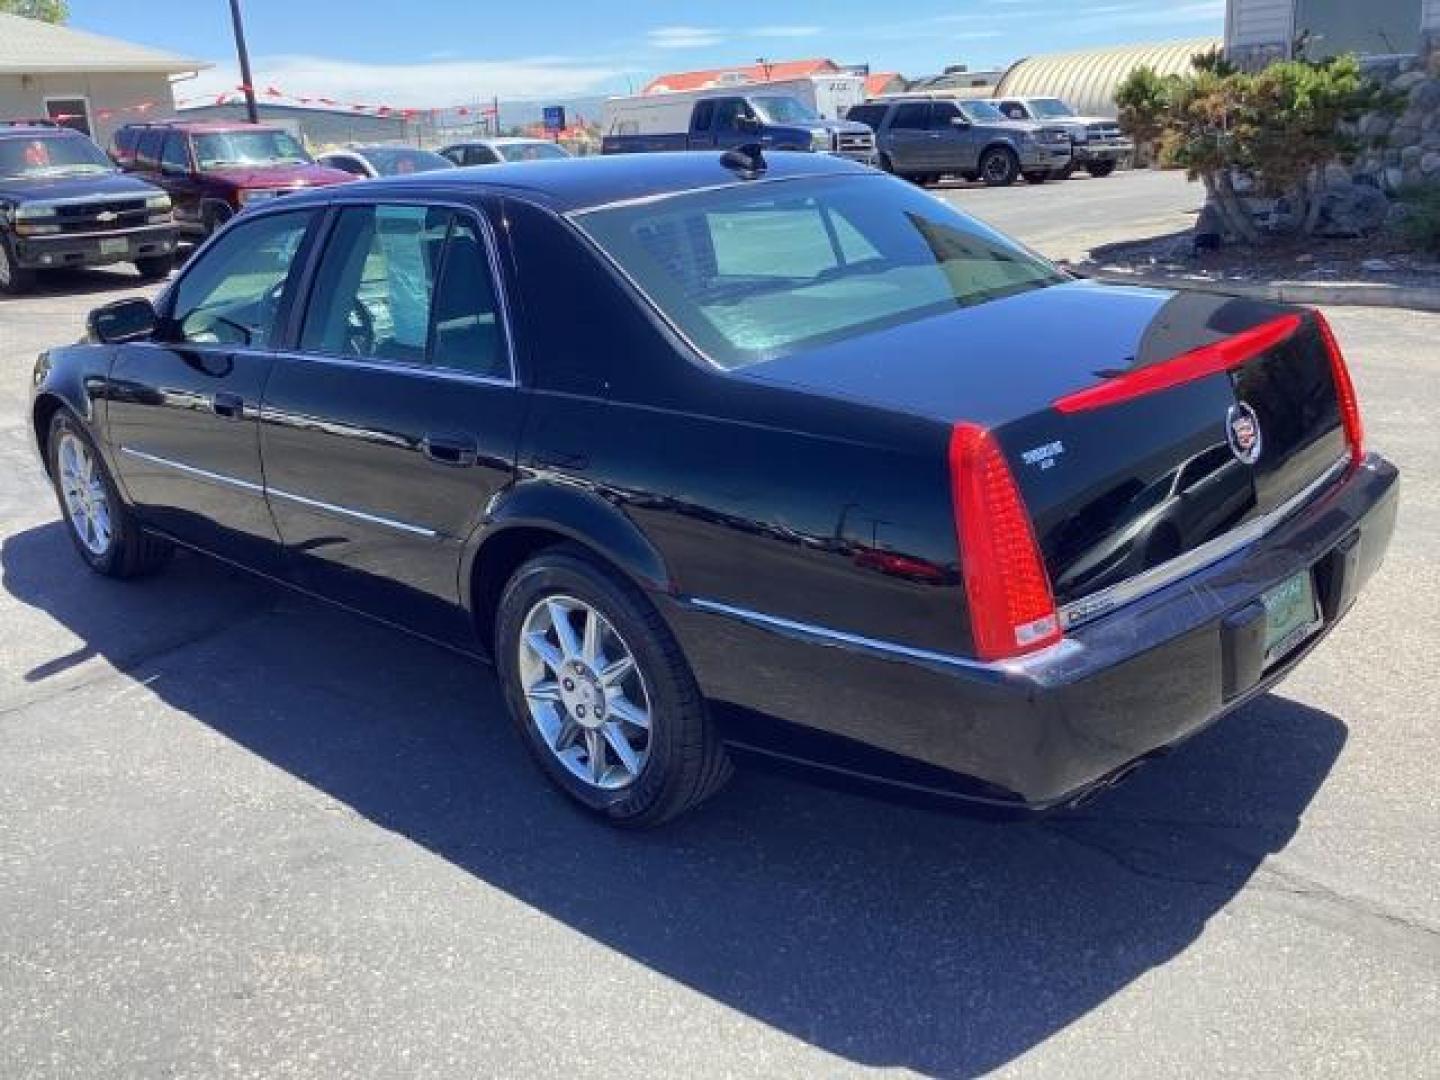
0,176,1440,1080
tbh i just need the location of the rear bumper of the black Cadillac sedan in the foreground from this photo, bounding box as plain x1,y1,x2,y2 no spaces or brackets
670,456,1398,811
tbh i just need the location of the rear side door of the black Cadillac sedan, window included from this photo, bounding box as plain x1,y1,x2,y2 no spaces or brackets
261,203,524,642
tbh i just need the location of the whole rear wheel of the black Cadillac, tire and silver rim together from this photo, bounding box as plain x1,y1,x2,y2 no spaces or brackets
495,544,732,828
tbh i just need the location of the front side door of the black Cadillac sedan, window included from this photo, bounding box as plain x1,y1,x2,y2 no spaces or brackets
107,210,318,569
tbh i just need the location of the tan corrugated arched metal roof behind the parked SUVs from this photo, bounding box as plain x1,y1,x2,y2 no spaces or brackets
994,37,1224,117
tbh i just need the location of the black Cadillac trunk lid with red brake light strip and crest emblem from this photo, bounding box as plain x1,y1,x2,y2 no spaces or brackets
747,282,1346,616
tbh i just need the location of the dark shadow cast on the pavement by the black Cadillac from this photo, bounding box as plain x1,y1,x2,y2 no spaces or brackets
0,523,1345,1076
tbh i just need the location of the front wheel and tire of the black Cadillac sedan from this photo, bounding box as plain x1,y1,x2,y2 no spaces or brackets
46,409,173,577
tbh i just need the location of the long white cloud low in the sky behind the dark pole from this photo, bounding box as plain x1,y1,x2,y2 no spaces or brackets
184,55,628,108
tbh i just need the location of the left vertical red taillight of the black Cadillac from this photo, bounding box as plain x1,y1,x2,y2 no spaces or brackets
950,423,1061,660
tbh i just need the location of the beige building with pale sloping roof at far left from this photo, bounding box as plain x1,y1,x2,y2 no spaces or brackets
0,14,210,145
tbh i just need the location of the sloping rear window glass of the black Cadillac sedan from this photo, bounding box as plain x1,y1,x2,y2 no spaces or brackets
575,176,1066,369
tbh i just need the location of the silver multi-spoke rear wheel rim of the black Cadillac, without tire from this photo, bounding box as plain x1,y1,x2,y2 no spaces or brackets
520,596,651,791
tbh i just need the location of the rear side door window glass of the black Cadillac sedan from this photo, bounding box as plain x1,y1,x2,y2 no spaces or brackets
301,206,510,377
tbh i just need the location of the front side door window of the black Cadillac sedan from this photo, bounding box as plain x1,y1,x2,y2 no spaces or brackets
167,210,315,348
